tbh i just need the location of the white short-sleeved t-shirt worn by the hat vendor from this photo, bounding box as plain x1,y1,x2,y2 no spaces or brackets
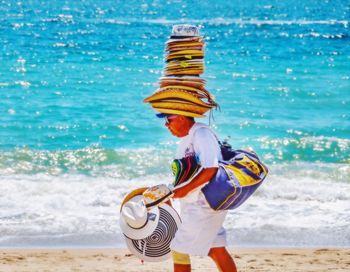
176,123,222,202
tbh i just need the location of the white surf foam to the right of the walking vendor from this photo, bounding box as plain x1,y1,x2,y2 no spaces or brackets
225,168,350,246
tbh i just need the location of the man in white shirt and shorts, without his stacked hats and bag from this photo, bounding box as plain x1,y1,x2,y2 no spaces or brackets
158,114,237,272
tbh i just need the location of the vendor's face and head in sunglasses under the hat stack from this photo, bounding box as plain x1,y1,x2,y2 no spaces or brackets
164,115,195,138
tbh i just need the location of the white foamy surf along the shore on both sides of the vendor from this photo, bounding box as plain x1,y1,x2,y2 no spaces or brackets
0,165,350,247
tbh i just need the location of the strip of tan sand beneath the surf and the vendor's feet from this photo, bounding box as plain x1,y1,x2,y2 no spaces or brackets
0,248,350,272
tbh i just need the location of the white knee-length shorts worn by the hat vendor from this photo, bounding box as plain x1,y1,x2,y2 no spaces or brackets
170,192,227,256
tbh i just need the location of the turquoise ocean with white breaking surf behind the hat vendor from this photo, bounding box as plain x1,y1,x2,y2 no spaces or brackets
0,0,350,247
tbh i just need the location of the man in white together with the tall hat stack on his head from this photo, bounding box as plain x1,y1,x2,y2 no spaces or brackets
145,25,236,272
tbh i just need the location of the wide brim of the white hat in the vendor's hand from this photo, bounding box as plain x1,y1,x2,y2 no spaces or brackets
119,195,159,239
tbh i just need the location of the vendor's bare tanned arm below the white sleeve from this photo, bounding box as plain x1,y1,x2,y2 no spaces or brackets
173,167,218,198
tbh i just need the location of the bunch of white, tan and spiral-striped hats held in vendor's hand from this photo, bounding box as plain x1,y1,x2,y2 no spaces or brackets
120,186,181,262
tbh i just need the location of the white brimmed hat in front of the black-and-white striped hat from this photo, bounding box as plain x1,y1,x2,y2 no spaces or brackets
120,195,159,239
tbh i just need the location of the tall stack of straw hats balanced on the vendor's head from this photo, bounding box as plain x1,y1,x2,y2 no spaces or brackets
144,25,218,117
